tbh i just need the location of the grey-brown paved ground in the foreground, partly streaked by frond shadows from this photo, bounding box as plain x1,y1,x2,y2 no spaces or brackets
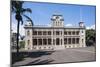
13,47,95,66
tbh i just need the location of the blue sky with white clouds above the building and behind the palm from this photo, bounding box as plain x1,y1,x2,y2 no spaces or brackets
12,2,96,35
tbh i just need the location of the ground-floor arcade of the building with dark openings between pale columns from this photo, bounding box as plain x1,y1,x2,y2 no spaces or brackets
28,37,83,50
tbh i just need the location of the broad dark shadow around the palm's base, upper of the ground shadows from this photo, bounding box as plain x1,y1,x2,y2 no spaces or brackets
11,51,54,64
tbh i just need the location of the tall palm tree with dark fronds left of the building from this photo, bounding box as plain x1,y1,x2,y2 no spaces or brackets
11,1,32,56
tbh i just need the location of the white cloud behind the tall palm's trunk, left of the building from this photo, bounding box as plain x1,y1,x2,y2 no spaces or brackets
11,22,25,35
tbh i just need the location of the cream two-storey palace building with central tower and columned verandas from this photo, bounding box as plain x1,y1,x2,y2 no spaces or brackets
24,15,86,50
